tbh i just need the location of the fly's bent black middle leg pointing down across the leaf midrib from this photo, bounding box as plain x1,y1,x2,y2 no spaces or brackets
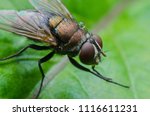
35,51,55,99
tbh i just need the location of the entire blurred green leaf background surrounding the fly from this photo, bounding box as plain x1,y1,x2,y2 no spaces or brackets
0,0,150,99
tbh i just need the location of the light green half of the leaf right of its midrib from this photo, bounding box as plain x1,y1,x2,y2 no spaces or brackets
39,1,150,99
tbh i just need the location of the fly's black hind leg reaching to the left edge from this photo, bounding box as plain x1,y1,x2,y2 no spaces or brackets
0,44,50,61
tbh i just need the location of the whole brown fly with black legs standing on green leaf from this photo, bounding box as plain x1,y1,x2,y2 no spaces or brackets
0,0,128,98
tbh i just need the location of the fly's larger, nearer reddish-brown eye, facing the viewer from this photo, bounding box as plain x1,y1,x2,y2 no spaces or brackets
79,42,95,65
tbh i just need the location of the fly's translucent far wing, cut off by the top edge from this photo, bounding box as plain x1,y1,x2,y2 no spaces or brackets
29,0,73,19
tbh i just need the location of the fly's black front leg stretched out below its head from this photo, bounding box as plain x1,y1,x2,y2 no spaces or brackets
68,56,129,88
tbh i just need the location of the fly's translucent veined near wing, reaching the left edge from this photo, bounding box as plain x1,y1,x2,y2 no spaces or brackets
0,10,56,45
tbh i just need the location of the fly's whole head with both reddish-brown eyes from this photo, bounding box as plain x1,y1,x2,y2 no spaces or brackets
79,34,106,66
